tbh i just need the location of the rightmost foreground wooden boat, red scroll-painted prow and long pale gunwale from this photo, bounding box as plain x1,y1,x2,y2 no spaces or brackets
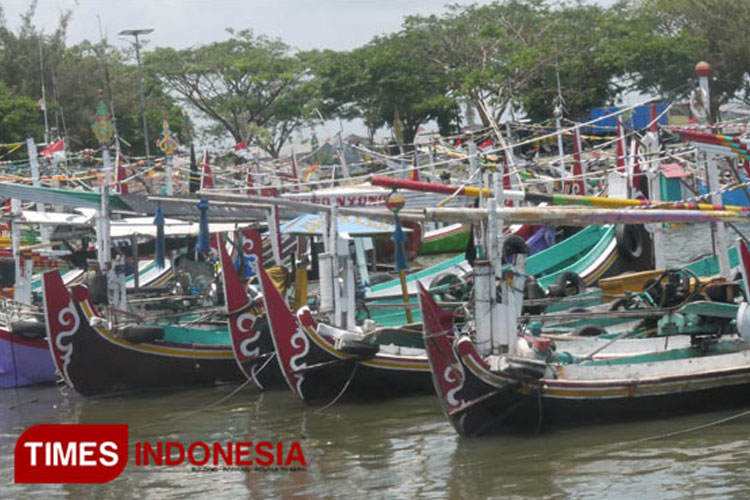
420,237,750,436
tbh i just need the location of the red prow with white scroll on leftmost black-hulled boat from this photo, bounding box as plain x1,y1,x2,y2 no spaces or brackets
42,270,81,387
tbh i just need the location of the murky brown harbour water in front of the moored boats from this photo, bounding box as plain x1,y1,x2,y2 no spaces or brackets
0,227,750,499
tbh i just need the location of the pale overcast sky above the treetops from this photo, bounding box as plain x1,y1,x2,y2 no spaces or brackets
5,0,500,50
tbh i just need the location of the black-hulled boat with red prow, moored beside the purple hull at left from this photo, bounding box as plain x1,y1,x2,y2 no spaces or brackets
42,271,243,396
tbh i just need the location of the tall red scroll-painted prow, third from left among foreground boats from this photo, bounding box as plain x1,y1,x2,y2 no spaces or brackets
251,259,310,399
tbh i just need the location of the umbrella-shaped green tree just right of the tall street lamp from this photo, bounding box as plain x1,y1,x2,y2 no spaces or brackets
146,30,312,157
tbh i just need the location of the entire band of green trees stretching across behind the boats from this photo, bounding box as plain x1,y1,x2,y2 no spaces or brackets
0,0,750,152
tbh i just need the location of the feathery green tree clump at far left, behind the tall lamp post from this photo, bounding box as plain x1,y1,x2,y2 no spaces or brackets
0,1,182,155
